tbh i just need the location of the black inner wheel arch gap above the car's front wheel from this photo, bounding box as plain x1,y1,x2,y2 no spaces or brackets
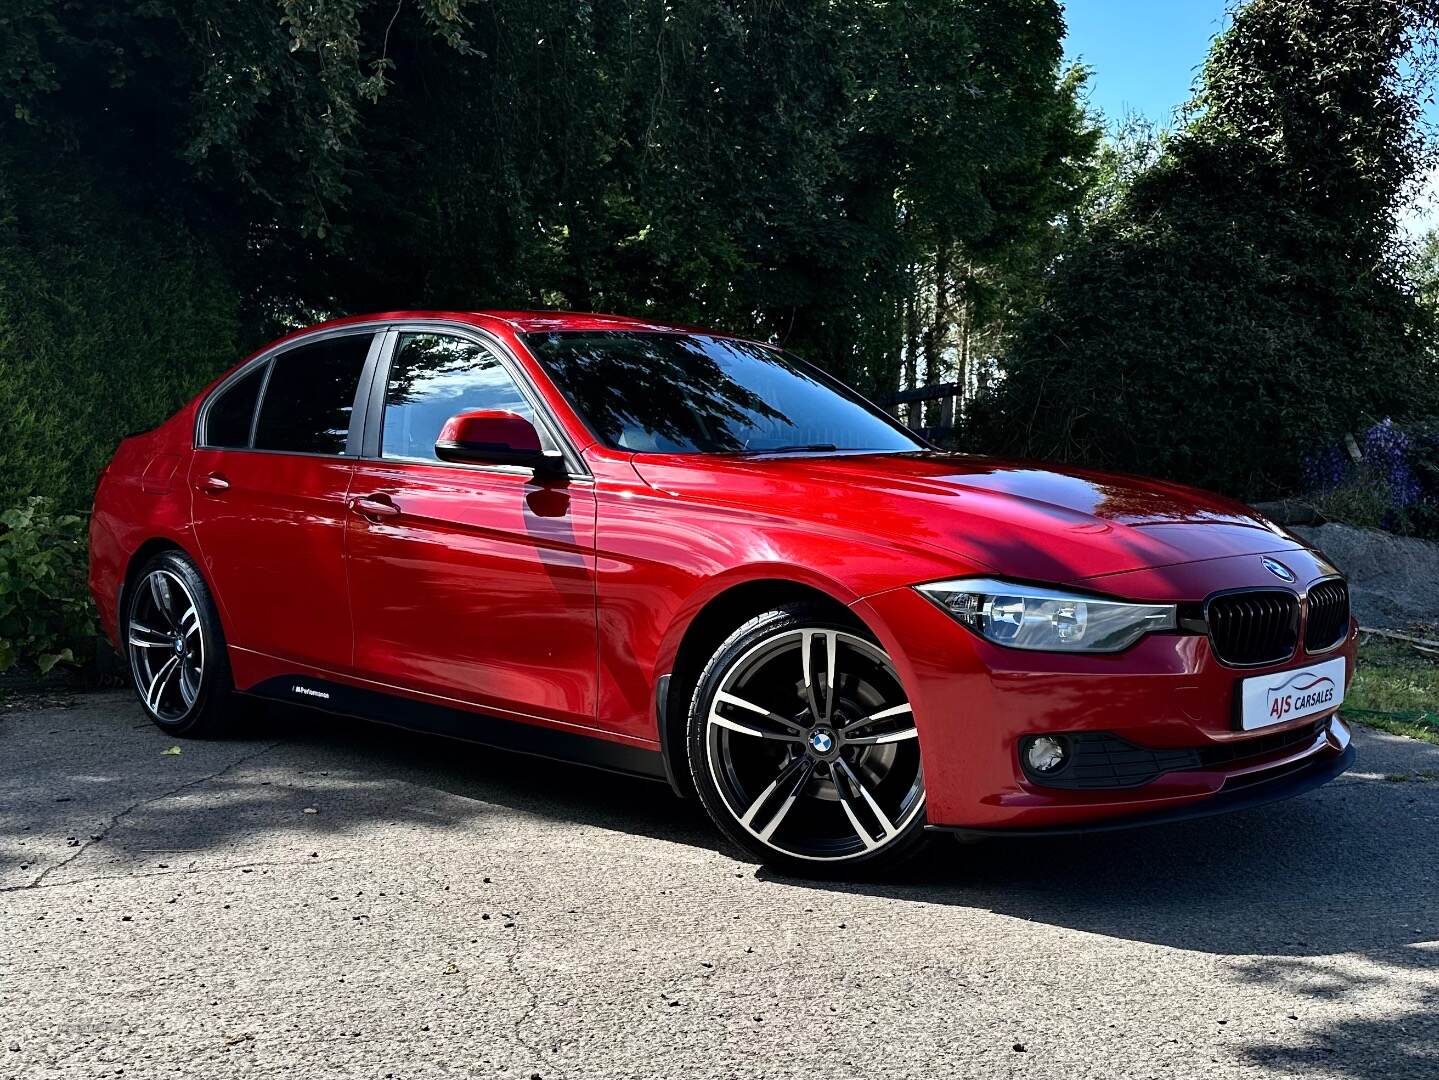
655,577,869,798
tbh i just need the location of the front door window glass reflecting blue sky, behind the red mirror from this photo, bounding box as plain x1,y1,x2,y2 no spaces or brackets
380,334,534,462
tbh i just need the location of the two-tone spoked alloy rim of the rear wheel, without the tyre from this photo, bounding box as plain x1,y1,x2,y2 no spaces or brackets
127,569,204,723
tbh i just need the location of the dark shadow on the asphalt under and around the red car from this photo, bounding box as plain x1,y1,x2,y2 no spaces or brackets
0,695,1439,1080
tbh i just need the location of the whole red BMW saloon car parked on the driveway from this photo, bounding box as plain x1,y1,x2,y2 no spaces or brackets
91,312,1356,873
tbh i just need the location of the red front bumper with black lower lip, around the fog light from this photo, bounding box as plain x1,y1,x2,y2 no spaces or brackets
853,575,1356,833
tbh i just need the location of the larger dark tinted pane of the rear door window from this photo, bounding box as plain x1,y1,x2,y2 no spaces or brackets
255,334,371,454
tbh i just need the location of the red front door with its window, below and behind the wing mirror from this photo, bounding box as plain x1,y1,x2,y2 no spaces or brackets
347,329,597,726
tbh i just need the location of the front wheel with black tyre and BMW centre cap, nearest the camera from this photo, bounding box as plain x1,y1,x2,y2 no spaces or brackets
688,605,925,877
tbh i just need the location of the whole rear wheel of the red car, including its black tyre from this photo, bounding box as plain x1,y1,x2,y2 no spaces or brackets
121,551,235,738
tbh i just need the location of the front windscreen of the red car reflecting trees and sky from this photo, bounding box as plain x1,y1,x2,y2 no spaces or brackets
525,331,922,453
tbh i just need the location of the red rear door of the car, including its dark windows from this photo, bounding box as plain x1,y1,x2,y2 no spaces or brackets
190,328,378,670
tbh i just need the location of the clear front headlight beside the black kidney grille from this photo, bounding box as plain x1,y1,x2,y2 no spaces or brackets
915,578,1179,653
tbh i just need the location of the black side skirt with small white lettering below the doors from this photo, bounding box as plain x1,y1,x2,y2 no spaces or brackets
243,674,666,781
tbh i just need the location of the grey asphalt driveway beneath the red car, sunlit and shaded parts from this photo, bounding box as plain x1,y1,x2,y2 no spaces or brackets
0,693,1439,1080
